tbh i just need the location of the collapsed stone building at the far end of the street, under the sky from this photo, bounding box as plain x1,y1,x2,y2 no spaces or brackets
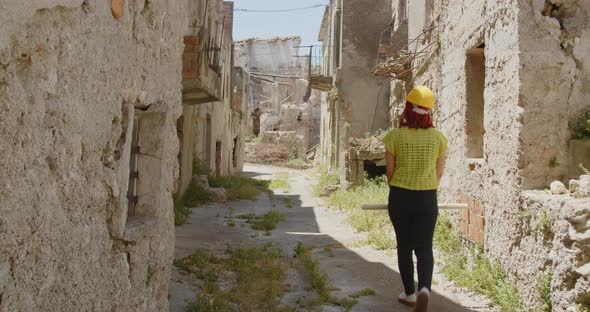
234,37,321,162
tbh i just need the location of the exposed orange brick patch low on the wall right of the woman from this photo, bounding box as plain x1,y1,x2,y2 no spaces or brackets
459,194,485,246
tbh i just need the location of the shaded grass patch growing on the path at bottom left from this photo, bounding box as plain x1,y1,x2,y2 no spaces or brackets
180,245,286,312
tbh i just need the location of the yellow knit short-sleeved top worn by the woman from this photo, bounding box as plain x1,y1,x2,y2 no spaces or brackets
383,127,448,191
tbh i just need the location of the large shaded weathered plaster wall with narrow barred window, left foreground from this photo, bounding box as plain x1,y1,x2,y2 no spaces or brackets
0,0,185,311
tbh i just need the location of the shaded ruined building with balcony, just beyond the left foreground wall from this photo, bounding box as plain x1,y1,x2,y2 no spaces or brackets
176,0,249,194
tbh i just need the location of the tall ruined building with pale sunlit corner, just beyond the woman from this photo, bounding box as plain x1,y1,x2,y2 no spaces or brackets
311,0,391,186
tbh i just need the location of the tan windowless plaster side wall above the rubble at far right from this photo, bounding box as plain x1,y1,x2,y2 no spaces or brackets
519,0,590,185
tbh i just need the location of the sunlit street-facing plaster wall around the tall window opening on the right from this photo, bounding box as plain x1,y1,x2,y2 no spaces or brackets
438,1,523,302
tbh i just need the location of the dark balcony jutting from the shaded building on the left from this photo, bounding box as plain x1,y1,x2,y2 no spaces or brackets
182,31,222,105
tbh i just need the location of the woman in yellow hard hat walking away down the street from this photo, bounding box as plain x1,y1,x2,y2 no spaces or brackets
383,86,447,312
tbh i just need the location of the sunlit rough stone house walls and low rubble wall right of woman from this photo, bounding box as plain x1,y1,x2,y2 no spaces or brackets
391,0,590,311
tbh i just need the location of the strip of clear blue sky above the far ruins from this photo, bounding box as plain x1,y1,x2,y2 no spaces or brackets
233,0,329,45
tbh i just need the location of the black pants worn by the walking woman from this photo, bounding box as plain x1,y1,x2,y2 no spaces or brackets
388,187,438,295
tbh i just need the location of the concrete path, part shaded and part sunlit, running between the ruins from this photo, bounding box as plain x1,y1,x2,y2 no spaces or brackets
169,165,493,312
